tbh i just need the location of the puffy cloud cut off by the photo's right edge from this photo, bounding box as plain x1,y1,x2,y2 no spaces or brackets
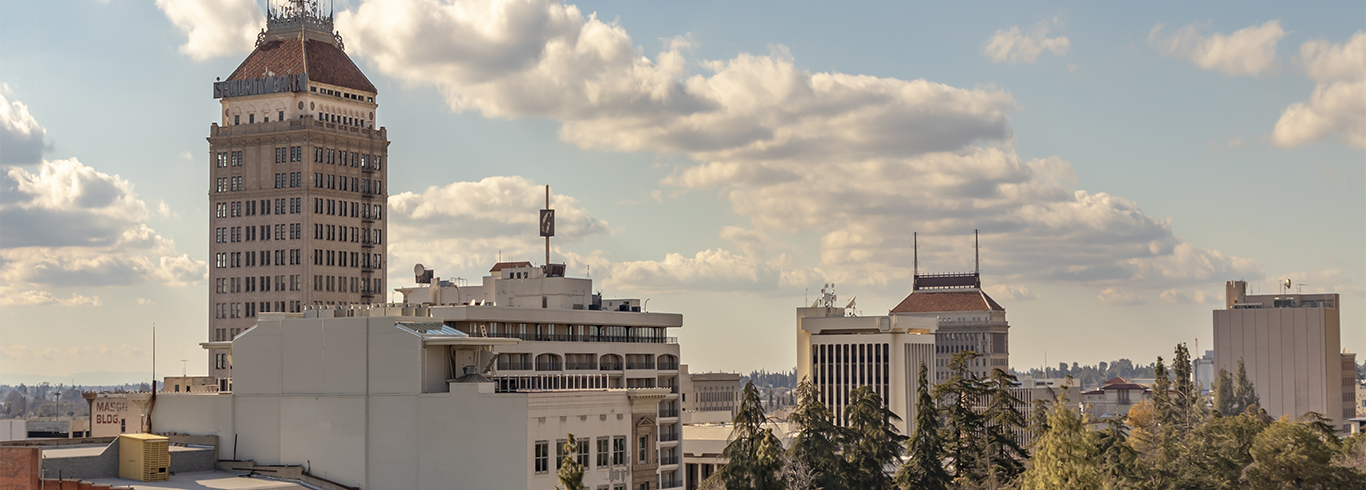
1272,31,1366,147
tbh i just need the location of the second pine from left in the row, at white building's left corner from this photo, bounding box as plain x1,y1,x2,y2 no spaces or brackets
787,378,844,490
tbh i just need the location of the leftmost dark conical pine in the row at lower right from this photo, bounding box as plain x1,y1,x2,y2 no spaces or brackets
717,381,783,490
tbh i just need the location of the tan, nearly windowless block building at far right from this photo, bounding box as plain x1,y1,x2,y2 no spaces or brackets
1214,281,1356,427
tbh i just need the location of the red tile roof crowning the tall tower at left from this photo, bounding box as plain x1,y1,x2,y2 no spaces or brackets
228,40,376,93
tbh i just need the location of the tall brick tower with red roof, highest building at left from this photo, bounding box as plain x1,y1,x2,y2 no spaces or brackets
205,0,389,390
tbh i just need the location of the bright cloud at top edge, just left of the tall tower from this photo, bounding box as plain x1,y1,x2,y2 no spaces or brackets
157,0,265,60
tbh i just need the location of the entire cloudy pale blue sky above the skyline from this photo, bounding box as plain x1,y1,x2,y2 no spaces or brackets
0,0,1366,384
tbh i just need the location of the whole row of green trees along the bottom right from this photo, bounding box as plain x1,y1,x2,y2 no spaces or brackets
701,344,1366,490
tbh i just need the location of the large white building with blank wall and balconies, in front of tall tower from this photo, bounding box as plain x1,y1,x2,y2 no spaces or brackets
166,265,683,490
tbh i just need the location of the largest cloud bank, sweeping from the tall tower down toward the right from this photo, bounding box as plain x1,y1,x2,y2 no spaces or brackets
337,0,1264,296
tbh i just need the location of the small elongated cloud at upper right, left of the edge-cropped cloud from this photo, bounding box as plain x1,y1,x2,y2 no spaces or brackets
1147,20,1285,76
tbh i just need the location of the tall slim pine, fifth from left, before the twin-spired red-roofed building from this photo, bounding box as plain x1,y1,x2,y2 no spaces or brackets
933,351,986,483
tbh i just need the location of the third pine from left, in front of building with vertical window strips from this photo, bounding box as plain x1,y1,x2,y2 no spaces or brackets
841,385,906,490
